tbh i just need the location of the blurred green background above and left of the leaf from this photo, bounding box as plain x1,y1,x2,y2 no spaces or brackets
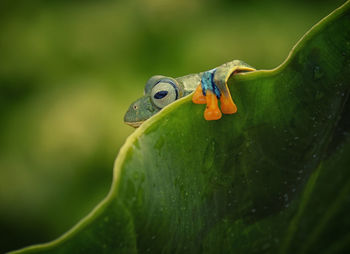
0,0,345,253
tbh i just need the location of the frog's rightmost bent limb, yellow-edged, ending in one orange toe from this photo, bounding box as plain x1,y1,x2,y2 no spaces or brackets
214,63,255,114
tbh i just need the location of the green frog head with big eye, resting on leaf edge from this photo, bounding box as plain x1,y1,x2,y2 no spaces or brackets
124,75,184,128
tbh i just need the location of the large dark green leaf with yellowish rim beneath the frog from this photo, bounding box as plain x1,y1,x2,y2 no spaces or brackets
10,2,350,253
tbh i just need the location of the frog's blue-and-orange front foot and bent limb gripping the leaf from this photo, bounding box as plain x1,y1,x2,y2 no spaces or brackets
192,62,255,121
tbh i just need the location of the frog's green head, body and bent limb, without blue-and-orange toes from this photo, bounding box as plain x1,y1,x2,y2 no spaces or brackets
124,60,254,128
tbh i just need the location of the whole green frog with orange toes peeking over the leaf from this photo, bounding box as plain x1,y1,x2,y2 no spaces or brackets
124,60,256,128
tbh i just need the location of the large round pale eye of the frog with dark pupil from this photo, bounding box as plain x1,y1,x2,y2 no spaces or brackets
151,80,179,108
